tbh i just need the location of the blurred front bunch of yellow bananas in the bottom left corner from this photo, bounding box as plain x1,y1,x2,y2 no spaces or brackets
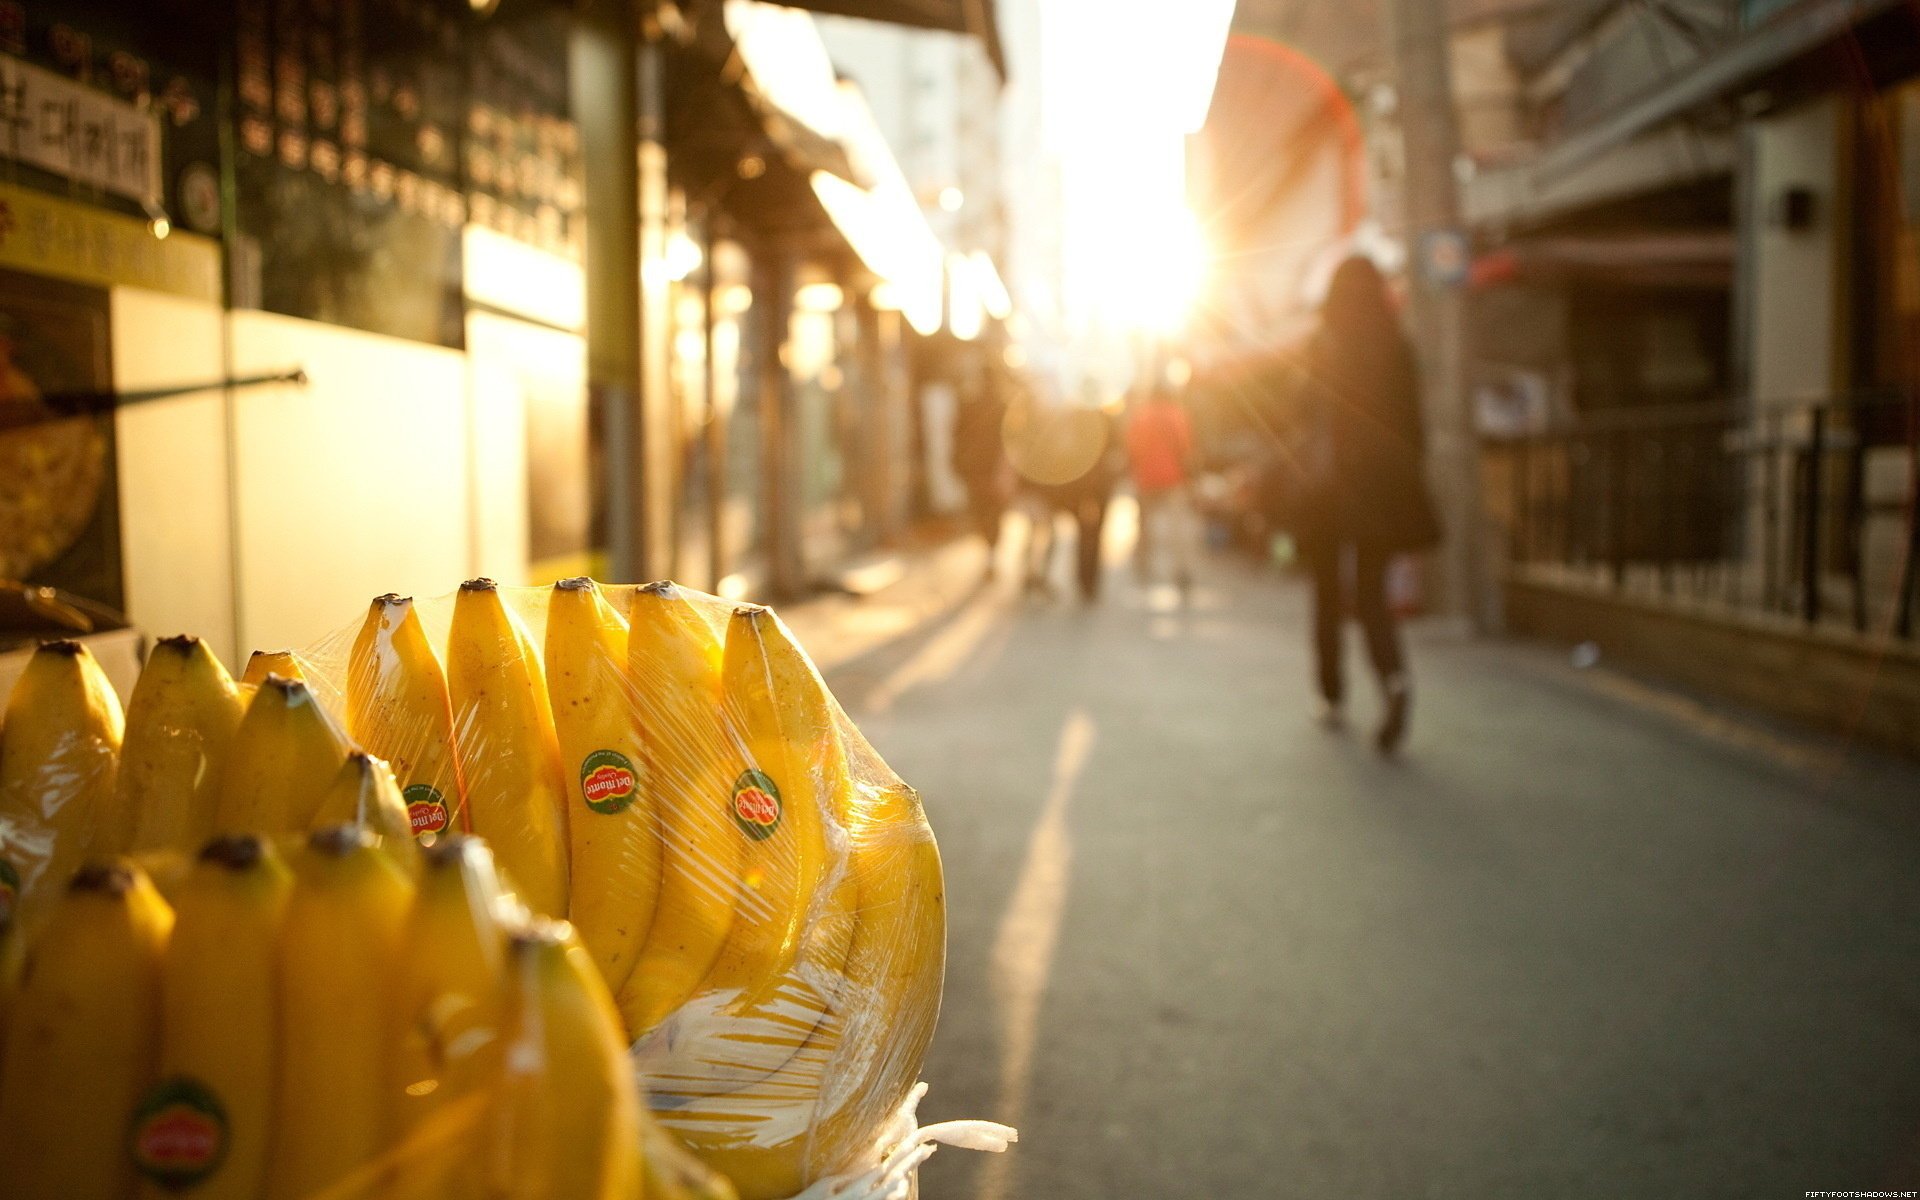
0,822,732,1200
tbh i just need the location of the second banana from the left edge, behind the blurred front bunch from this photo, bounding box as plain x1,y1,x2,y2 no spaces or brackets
111,636,246,854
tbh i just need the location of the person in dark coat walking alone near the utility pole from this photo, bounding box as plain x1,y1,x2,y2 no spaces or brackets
1294,257,1440,753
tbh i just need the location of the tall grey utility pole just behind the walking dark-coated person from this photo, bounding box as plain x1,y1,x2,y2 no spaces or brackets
1386,0,1492,630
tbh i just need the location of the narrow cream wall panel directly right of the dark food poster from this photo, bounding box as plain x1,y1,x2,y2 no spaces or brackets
108,288,240,664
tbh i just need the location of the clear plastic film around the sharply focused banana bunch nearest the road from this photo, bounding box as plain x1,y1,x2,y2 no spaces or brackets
301,580,945,1200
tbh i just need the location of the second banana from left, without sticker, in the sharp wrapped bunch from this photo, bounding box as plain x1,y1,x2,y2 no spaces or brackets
447,580,566,916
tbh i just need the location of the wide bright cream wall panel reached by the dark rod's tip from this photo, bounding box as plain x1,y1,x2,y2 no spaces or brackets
230,311,472,651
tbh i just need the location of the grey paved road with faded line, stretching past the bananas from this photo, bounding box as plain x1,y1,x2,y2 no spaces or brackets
797,529,1920,1200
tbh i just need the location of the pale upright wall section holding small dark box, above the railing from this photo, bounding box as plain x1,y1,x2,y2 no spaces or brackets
1743,96,1843,405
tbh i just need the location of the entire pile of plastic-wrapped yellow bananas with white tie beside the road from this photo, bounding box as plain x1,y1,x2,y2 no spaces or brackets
0,578,1014,1200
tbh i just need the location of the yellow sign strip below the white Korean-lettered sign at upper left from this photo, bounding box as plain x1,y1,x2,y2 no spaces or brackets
0,184,221,303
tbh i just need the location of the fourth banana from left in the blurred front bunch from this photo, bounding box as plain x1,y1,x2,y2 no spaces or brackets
397,835,507,1167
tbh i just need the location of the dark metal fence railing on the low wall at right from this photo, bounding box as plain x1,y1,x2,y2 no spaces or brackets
1482,394,1920,637
